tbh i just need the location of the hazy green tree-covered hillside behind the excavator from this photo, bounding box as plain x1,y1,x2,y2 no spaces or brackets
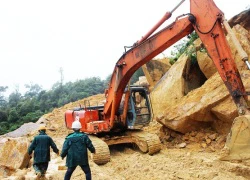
0,73,146,134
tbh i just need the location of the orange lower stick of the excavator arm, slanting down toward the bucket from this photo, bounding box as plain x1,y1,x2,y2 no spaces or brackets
190,0,249,115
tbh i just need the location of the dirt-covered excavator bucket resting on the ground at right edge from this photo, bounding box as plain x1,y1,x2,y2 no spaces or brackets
220,115,250,160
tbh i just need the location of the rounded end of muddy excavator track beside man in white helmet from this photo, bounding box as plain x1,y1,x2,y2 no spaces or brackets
89,135,110,165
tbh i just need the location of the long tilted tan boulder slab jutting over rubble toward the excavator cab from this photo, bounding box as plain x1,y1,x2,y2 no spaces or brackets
156,74,226,133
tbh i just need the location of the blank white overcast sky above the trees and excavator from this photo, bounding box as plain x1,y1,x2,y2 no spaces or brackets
0,0,250,92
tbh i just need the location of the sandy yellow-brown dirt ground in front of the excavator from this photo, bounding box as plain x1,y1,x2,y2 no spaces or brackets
5,122,250,180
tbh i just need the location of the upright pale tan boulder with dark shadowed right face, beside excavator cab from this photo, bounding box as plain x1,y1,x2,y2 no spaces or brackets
151,49,206,117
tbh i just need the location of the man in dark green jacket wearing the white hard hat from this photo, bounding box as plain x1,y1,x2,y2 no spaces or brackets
61,120,95,180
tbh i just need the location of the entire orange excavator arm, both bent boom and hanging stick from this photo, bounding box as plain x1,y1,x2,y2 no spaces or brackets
104,0,249,128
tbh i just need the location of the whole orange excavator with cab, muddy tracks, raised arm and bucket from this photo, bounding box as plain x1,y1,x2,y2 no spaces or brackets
65,0,250,164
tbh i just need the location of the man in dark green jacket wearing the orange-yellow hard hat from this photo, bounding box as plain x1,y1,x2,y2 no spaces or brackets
28,125,59,179
